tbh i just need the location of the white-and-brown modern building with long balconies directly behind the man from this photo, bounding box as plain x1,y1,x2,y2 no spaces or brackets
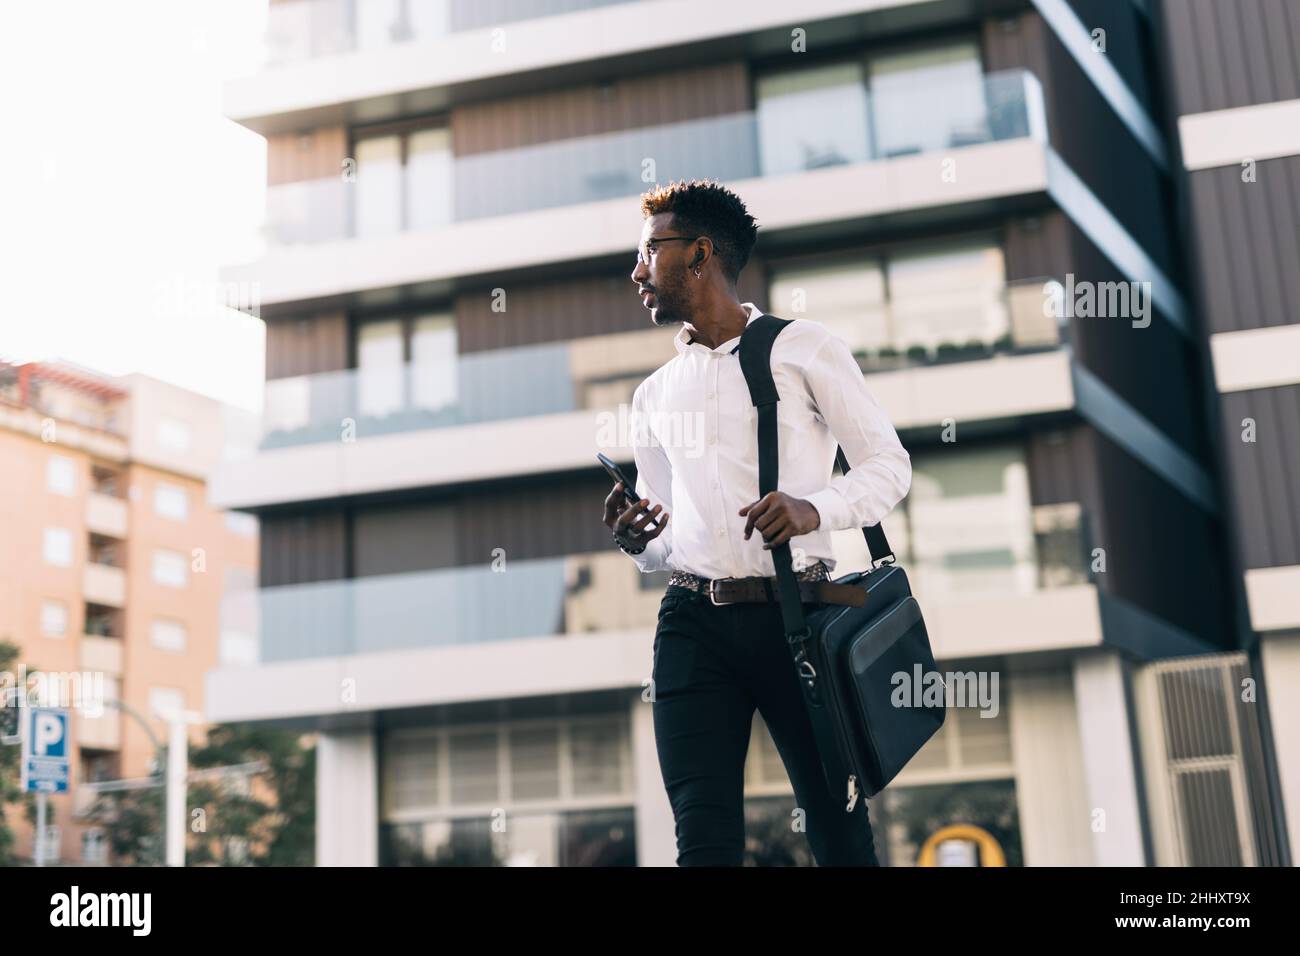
208,0,1281,865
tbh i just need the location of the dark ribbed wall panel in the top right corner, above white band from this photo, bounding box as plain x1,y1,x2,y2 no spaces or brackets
1153,0,1300,113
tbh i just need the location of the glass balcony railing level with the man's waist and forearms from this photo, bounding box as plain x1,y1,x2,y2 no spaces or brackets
231,496,1089,663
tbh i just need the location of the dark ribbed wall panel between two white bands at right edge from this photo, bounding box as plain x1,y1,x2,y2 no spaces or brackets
1188,156,1300,333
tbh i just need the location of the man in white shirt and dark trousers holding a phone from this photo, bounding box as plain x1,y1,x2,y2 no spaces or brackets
605,181,911,866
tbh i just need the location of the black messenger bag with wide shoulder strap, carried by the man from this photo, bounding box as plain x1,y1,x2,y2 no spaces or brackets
740,315,946,813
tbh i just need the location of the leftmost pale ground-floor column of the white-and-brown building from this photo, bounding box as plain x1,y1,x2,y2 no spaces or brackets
316,730,380,866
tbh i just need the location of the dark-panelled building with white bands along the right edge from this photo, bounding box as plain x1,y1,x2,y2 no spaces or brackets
1160,0,1300,860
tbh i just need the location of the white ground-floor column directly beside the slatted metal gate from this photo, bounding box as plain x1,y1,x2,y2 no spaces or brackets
1074,649,1147,866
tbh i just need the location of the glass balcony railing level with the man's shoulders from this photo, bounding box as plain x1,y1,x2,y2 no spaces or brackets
261,278,1061,449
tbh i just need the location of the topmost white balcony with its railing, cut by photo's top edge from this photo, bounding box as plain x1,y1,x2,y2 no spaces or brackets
222,0,982,134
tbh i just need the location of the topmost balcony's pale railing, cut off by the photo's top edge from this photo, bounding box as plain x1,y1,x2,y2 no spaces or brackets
267,0,644,66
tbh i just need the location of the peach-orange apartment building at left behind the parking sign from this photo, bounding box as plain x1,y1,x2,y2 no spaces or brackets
0,362,257,864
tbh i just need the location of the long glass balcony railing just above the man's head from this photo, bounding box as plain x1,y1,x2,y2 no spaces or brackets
267,70,1047,245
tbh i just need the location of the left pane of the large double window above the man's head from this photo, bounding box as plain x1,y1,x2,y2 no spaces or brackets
757,62,871,176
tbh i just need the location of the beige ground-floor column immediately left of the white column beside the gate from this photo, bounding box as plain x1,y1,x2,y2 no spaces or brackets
1004,666,1095,866
